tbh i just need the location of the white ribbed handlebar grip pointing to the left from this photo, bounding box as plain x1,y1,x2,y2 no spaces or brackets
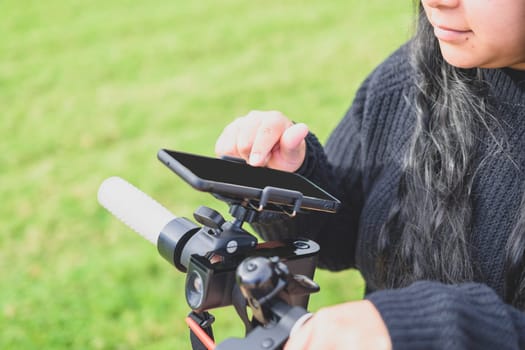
98,176,176,245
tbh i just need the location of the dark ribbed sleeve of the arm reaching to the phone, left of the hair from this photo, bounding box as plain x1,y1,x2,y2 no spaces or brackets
252,42,410,271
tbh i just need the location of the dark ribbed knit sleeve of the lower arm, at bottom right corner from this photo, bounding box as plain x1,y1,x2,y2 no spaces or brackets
367,281,525,350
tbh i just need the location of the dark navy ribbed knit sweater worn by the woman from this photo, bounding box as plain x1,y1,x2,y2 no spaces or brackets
254,46,525,349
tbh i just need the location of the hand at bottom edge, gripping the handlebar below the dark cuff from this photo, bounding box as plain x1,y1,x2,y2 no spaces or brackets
284,300,392,350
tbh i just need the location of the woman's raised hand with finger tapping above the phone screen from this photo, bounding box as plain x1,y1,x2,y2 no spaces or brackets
215,111,308,172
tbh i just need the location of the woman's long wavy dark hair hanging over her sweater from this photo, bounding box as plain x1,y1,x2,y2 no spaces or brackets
372,1,525,307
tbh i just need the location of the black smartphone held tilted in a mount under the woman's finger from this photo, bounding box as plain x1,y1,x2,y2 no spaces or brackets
157,149,340,212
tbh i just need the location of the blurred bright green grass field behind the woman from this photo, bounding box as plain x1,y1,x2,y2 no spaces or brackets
0,0,412,349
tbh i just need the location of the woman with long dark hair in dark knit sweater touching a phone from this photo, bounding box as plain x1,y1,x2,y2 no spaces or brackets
216,0,525,350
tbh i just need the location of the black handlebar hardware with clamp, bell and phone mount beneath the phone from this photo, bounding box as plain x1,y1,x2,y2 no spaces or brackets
157,193,319,350
